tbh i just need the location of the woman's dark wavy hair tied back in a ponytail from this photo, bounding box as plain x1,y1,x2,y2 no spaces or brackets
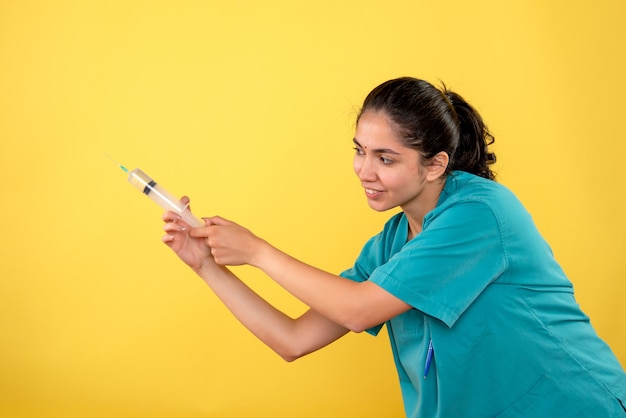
357,77,496,180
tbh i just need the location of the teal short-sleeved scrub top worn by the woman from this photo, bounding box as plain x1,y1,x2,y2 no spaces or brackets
342,171,626,418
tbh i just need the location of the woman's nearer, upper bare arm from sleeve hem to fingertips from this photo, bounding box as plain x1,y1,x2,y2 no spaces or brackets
190,217,411,332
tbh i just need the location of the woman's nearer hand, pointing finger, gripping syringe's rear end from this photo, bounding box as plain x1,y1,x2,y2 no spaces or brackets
190,216,266,267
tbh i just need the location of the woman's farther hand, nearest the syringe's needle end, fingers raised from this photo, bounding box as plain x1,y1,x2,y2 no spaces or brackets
162,196,214,272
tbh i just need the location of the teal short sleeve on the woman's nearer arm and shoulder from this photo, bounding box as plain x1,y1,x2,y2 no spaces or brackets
369,200,506,327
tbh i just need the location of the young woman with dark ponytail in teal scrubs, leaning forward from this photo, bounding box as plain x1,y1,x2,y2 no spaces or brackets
163,78,626,417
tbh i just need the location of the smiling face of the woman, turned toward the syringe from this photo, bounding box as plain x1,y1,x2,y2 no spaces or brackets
354,111,426,212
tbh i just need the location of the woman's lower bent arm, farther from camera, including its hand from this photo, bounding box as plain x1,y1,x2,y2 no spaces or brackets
163,207,348,361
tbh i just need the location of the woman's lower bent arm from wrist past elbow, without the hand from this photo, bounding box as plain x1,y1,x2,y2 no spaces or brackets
197,265,348,361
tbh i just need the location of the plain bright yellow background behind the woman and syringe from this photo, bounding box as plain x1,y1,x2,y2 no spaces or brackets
0,0,626,418
